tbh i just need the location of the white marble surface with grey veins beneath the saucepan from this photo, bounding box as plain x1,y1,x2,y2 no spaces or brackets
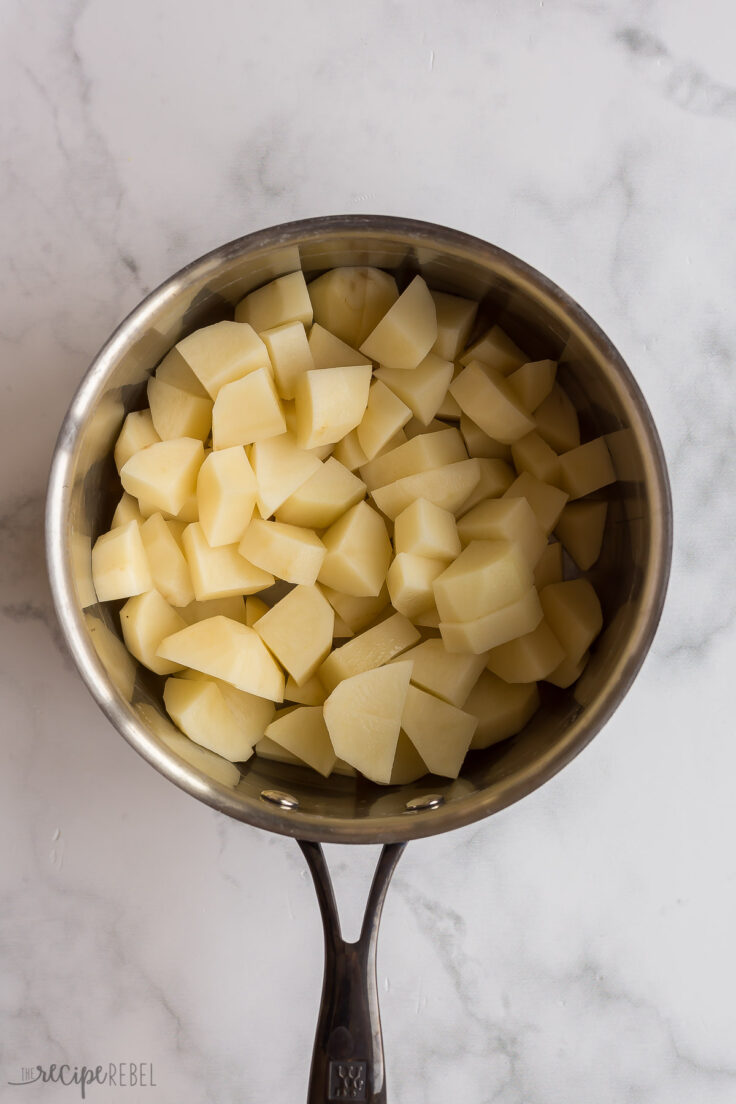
0,0,736,1104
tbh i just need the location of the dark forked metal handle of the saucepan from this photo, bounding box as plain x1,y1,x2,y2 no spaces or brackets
298,840,406,1104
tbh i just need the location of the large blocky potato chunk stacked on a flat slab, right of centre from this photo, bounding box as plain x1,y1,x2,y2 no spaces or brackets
434,541,532,627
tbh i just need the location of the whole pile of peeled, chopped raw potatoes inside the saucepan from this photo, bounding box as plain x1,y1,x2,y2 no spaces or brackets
93,267,615,784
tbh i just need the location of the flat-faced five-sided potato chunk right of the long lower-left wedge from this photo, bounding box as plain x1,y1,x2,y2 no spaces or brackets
255,586,334,684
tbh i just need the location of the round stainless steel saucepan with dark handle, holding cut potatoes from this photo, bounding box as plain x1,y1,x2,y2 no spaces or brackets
46,215,672,1104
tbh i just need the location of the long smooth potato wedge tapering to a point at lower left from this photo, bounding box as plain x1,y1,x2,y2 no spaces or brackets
158,617,284,701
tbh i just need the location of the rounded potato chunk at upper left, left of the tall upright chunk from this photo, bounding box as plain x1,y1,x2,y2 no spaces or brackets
120,437,204,517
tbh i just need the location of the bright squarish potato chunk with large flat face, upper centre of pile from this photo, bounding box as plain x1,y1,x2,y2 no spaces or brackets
295,364,371,448
